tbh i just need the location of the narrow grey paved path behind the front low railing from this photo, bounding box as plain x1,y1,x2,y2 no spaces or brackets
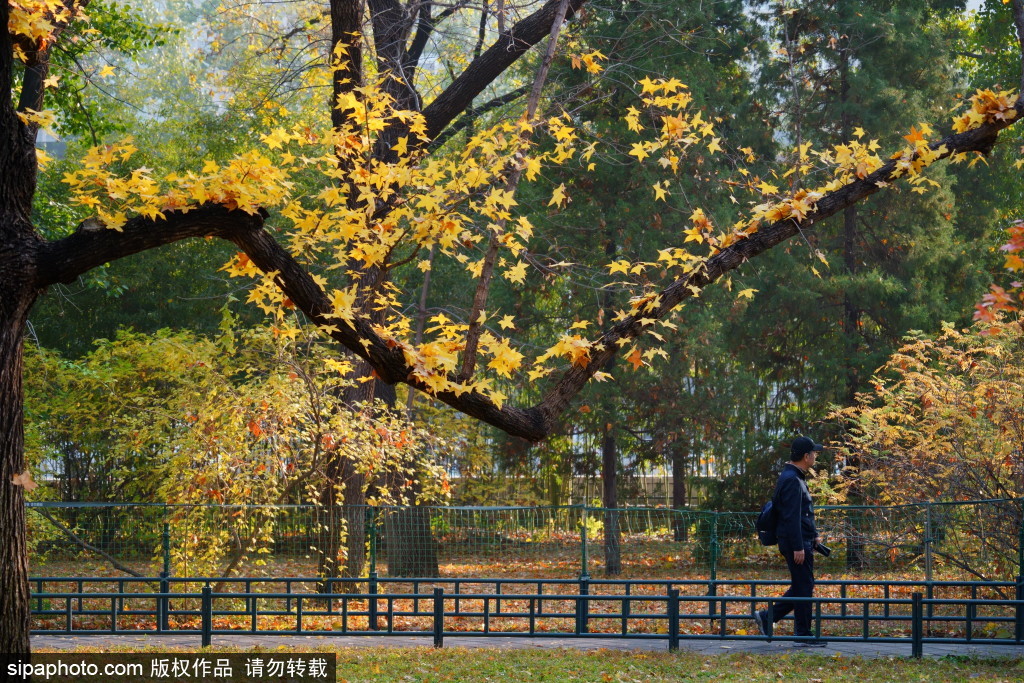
32,635,1024,658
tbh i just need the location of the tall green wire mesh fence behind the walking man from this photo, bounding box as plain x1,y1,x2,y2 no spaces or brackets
29,500,1024,581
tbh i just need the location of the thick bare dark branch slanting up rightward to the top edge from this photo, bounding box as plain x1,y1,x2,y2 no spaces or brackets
423,0,586,138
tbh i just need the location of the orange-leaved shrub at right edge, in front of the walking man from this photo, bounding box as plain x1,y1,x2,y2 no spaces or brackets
833,316,1024,579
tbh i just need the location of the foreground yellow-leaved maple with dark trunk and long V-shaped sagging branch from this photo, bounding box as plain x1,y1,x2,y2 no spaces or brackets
6,0,1024,652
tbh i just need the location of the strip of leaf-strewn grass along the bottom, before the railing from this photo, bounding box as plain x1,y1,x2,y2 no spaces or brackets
37,647,1024,683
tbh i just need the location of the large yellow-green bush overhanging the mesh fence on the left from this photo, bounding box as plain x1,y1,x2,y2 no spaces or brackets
27,321,449,577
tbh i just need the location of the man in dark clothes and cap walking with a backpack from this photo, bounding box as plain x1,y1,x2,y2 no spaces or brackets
754,436,825,647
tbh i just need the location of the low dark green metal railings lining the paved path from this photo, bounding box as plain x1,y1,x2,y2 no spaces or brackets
32,578,1024,656
